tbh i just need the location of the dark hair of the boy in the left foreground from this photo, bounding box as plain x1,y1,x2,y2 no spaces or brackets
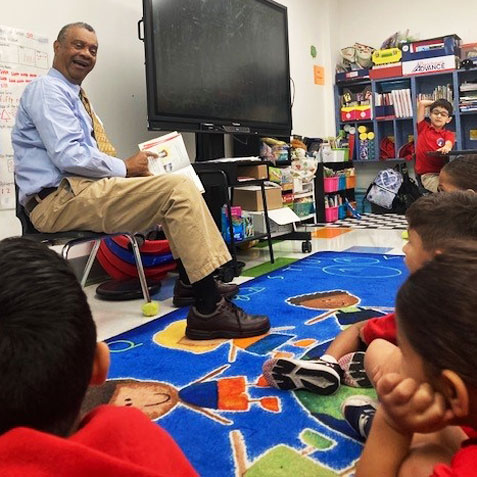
0,238,96,436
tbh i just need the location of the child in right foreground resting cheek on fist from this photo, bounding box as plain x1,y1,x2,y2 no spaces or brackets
356,242,477,477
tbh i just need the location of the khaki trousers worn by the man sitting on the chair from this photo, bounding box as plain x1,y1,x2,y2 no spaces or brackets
30,174,231,283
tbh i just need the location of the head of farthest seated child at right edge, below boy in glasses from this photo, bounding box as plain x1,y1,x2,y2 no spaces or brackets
439,154,477,192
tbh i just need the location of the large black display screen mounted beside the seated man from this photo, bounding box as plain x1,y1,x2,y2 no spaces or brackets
140,0,291,135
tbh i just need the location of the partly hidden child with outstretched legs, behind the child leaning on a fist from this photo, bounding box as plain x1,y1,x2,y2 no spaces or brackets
263,191,477,395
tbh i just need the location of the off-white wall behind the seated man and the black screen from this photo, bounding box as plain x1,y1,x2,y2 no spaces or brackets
0,0,337,239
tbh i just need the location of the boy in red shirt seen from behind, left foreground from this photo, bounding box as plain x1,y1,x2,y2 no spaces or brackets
0,238,198,477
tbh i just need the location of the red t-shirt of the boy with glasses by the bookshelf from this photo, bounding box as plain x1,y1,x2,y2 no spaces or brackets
415,119,455,175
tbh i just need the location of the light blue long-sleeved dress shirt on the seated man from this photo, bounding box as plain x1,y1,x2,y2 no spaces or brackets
12,68,126,204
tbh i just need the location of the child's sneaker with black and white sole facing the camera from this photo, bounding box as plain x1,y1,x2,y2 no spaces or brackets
263,358,343,395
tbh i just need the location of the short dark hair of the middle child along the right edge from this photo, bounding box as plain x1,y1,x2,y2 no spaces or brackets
406,191,477,251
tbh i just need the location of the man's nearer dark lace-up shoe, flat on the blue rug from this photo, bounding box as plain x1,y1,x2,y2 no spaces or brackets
186,298,270,340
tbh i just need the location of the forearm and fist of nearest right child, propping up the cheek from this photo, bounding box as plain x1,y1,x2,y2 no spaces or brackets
356,374,454,477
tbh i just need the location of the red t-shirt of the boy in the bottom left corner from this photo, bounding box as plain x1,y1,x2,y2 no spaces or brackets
0,406,198,477
